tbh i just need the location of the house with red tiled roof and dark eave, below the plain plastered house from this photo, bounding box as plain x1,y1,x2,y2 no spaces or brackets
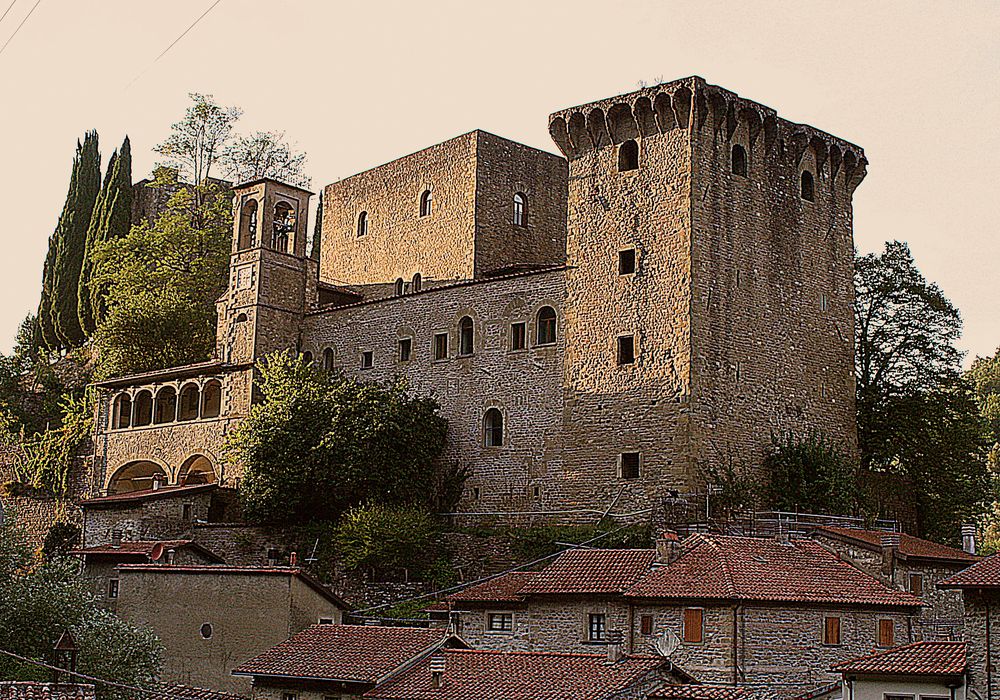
233,625,467,700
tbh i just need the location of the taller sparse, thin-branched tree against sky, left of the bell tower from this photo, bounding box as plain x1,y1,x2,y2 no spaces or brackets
154,93,243,185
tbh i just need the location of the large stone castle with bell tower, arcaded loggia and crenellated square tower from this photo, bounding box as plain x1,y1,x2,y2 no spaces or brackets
93,77,867,513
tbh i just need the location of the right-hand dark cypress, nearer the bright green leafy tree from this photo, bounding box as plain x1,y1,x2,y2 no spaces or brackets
77,136,132,337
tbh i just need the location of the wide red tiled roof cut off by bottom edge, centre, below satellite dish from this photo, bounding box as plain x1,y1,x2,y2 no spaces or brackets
365,649,667,700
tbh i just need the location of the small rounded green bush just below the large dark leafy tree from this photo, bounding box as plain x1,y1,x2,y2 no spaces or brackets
334,503,441,580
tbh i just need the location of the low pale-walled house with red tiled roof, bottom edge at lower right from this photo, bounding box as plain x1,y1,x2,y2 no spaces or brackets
833,640,968,700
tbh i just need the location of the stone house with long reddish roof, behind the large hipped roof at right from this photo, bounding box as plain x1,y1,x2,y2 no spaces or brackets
811,526,979,639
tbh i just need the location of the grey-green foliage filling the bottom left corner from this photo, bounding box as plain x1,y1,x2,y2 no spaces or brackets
0,519,162,700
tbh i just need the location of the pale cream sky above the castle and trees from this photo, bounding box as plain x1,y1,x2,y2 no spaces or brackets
0,0,1000,362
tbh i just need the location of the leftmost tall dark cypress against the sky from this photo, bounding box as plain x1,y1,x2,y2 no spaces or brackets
43,131,101,348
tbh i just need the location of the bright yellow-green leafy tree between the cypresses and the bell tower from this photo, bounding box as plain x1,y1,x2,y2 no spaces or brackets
92,170,231,377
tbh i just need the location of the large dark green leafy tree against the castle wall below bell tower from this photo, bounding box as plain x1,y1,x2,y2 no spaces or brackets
227,353,447,523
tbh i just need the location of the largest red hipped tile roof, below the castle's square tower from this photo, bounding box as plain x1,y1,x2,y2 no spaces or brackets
625,535,923,607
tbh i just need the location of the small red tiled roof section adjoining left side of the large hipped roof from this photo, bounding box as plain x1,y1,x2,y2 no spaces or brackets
520,549,656,595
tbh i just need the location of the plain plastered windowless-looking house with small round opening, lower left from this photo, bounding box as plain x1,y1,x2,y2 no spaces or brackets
117,564,348,695
